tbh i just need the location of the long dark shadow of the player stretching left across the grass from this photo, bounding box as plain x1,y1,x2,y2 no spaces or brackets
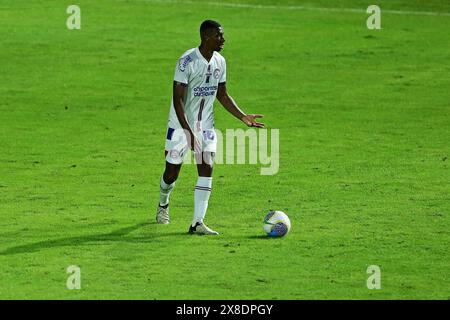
0,222,187,255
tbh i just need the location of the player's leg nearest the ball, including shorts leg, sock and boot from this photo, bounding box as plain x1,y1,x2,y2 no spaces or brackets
189,127,218,235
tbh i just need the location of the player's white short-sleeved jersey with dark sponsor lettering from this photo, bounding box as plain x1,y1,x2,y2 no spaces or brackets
169,48,226,131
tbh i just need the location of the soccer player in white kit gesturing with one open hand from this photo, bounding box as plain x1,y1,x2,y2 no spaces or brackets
156,20,264,235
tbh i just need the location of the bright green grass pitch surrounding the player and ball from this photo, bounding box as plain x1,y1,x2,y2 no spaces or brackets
0,0,450,299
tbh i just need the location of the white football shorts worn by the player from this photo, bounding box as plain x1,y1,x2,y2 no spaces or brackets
166,127,217,164
